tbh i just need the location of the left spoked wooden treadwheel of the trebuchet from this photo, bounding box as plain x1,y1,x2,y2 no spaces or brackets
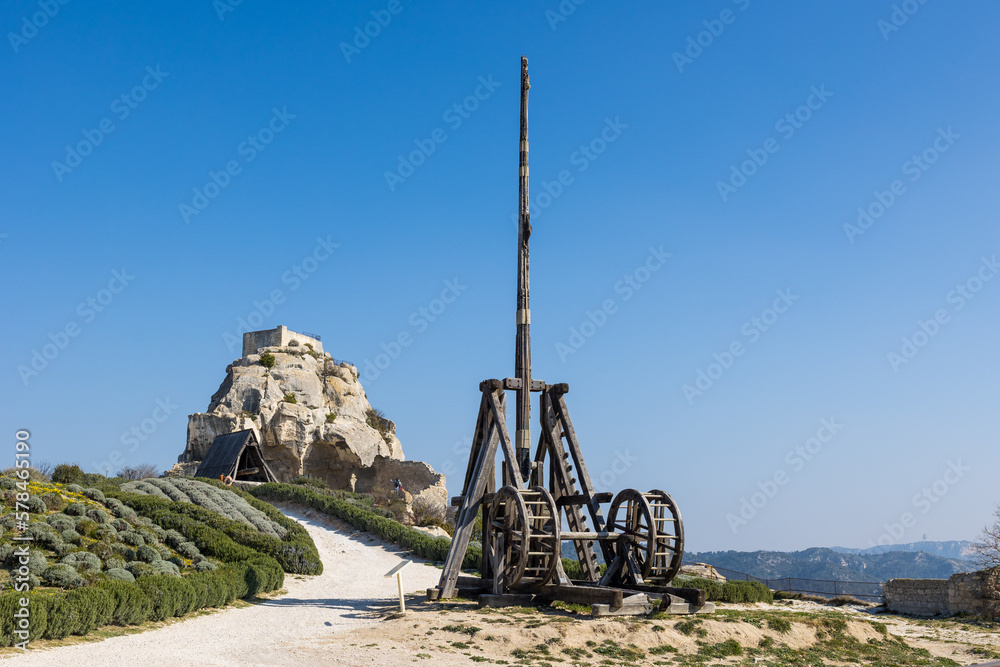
490,485,561,587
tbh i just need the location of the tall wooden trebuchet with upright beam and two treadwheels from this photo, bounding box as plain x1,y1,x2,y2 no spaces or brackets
428,58,707,614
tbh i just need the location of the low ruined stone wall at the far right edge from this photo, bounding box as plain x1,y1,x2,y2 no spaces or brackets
883,568,1000,617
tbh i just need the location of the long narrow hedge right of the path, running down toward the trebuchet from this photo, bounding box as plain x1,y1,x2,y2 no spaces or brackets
250,482,482,569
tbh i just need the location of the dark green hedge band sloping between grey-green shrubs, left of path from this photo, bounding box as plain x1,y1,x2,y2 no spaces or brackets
109,491,323,574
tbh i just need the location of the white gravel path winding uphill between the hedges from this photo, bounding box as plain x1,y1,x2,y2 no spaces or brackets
2,508,441,667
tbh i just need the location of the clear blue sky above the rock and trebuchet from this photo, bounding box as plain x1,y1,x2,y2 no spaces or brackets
0,0,1000,550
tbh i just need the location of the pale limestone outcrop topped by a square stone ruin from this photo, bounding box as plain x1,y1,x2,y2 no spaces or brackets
176,327,448,506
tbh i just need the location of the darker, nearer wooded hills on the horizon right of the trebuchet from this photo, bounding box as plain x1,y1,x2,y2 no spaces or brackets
684,548,979,582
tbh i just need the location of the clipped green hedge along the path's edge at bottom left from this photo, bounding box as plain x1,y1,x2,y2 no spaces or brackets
0,559,282,646
